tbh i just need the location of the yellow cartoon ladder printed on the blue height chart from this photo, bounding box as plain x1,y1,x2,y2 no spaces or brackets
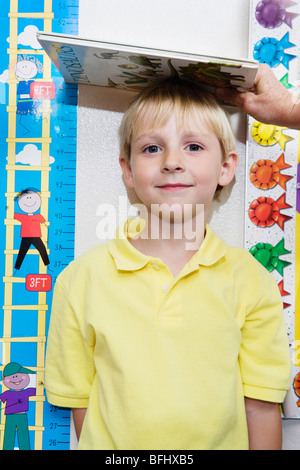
0,0,54,450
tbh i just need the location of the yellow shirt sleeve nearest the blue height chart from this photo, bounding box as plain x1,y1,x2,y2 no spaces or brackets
45,270,95,408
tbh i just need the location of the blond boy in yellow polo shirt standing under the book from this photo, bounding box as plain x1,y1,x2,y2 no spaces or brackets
46,80,290,450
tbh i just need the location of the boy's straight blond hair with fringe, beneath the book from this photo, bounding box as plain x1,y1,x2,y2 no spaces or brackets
119,79,235,162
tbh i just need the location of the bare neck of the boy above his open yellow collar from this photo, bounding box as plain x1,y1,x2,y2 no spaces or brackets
130,211,205,277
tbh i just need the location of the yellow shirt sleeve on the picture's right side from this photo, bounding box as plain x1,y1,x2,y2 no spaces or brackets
239,273,291,403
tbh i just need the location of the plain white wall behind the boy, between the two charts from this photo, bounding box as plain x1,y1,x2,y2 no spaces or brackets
74,0,300,449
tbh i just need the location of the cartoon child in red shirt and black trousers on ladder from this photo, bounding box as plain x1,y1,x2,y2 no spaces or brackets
14,189,50,269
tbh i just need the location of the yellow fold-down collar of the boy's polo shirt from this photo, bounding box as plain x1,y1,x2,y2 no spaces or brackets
108,219,227,271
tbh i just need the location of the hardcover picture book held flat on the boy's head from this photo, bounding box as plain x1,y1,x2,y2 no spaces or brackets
37,31,258,92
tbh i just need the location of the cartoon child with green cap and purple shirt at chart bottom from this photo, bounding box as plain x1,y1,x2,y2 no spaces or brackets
0,362,36,450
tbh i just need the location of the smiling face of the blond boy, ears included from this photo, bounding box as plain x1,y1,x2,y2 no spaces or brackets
120,113,238,220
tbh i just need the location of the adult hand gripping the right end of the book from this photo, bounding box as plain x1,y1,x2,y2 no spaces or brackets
216,64,300,129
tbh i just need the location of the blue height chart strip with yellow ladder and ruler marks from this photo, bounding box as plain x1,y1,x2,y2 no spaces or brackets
0,0,78,450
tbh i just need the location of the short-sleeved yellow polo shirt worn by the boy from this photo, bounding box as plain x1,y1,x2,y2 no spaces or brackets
46,223,290,450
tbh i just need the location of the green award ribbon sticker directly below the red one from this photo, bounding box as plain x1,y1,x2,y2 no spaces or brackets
249,238,291,276
